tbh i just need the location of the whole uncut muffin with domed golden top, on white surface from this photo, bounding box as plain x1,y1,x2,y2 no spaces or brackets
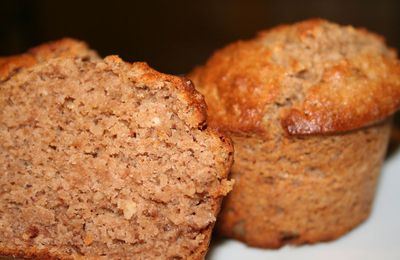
189,19,400,248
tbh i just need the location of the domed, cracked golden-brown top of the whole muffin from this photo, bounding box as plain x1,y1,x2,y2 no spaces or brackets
189,19,400,135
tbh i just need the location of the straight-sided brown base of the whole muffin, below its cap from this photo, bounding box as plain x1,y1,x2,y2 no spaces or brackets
217,120,391,248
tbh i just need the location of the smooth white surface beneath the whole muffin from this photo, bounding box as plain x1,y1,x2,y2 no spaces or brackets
207,150,400,260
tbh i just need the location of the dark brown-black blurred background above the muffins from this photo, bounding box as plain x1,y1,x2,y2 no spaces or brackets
0,0,400,74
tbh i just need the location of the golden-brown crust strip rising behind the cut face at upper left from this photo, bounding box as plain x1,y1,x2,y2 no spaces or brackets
0,38,97,82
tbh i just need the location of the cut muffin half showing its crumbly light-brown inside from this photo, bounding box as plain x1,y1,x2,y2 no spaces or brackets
0,40,232,259
